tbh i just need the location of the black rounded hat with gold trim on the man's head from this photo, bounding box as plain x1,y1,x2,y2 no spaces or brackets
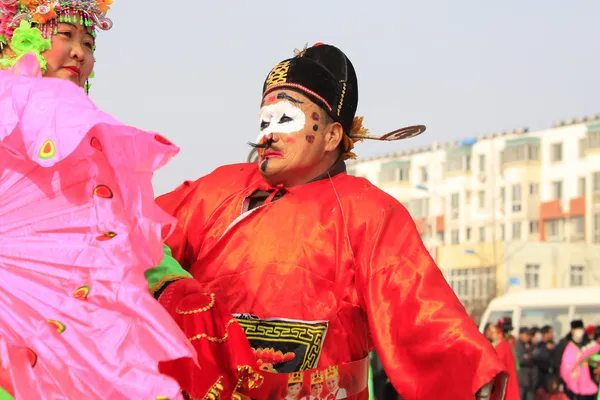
263,43,358,133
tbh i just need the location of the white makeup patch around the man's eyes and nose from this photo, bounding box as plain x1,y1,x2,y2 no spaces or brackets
256,101,306,143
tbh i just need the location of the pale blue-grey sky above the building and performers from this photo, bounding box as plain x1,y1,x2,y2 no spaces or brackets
91,0,600,193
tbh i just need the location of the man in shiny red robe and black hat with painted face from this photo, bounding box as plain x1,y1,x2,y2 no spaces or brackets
154,44,504,400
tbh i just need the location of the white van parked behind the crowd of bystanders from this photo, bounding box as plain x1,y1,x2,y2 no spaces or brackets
479,287,600,340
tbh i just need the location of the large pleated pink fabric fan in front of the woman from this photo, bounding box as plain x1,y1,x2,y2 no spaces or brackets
0,56,196,400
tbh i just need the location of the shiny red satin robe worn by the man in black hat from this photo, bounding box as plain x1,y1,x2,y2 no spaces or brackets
157,163,504,400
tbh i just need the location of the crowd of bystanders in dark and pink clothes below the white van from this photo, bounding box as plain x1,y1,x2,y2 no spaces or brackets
485,318,600,400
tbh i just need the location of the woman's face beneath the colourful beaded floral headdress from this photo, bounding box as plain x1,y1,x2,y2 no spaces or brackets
43,22,94,86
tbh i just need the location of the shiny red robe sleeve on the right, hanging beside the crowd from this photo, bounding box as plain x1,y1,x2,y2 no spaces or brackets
354,200,504,400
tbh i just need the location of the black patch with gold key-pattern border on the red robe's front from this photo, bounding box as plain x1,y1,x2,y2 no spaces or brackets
234,314,328,373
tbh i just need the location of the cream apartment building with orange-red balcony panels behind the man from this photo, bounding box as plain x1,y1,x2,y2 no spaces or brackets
348,114,600,310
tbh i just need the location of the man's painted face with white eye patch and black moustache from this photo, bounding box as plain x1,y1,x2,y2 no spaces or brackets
258,89,343,186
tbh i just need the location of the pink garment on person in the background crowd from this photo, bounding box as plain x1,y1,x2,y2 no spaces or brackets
560,342,598,396
